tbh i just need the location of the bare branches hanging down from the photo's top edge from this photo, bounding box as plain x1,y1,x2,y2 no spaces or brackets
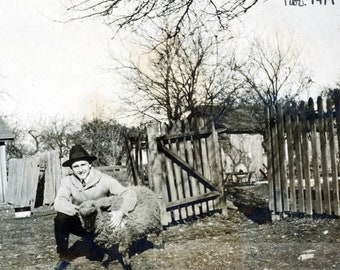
65,0,259,37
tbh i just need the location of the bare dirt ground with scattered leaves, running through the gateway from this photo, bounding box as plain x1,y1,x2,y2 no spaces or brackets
0,184,340,270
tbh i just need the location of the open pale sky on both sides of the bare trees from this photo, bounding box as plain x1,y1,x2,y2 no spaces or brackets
0,0,340,125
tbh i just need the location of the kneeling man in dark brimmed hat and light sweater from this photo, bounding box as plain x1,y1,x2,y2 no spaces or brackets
54,145,137,269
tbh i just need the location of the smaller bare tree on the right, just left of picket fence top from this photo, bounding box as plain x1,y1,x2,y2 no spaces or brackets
235,37,312,106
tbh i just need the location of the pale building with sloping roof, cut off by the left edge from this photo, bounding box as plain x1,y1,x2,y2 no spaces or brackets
0,118,14,202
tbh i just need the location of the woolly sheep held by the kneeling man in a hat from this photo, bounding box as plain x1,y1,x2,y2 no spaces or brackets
79,186,164,266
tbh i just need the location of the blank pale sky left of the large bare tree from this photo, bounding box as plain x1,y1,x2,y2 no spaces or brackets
0,0,119,123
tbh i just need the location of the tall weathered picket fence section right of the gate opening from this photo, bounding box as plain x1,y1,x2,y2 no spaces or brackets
266,97,340,216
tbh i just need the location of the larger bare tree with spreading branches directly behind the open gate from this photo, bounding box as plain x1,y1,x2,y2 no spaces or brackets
118,25,240,121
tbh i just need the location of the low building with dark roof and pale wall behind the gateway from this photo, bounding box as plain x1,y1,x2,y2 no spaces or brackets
191,105,267,181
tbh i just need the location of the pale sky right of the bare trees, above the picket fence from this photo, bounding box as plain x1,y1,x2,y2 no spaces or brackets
247,0,340,97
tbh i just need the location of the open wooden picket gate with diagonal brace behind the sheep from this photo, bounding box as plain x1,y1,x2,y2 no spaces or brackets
147,119,226,225
